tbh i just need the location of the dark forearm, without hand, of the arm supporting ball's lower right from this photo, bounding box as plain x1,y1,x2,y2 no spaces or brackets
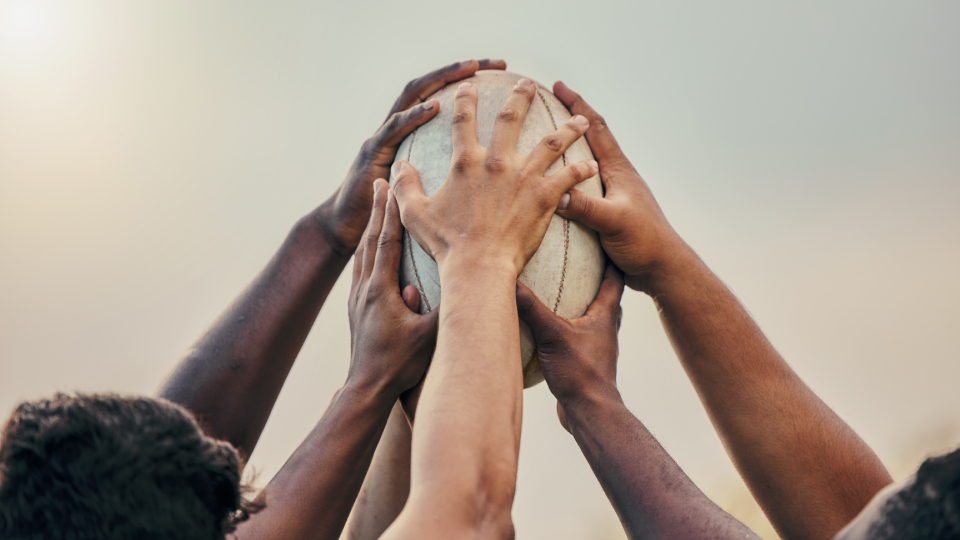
564,395,756,539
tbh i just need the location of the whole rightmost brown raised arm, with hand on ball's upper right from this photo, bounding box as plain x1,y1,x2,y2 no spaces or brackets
554,83,892,540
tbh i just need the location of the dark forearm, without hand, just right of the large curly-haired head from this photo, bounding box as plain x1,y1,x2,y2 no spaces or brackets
237,382,396,540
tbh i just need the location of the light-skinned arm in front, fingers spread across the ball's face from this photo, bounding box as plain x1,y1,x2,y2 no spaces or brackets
383,80,596,539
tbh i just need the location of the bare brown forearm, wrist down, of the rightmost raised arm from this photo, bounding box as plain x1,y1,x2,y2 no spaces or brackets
650,250,891,539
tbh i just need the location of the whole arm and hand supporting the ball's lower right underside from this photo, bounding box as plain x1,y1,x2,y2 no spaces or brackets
517,264,757,540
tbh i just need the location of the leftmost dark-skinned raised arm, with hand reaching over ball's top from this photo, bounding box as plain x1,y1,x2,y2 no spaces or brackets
158,60,506,457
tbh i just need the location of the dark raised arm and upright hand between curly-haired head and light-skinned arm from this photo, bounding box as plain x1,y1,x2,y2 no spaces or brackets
238,180,438,540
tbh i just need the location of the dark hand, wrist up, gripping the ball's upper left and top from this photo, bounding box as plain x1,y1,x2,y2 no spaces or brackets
316,60,507,256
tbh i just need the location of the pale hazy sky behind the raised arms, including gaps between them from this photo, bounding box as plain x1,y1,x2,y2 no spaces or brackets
0,0,960,540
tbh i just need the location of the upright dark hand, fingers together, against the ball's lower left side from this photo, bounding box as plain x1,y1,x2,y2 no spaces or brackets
347,179,439,399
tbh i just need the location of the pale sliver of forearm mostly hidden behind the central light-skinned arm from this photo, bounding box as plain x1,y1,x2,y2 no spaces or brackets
341,402,412,540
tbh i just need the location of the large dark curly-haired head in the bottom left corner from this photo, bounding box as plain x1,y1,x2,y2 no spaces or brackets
0,394,258,540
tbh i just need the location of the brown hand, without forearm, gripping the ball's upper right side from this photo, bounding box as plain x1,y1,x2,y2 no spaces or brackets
553,82,689,293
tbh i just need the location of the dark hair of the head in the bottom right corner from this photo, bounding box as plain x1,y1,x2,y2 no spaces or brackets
869,448,960,540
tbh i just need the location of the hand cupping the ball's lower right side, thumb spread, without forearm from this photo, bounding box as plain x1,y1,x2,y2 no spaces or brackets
517,263,623,431
